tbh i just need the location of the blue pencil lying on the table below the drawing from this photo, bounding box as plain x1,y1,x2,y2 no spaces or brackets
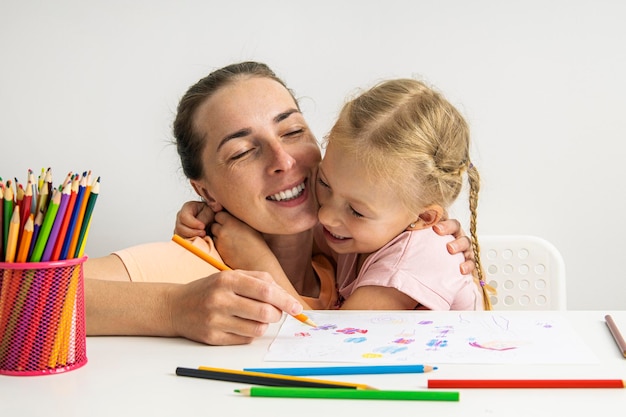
243,365,437,376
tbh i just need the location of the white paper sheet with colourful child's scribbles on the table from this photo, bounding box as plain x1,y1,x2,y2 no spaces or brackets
265,311,598,364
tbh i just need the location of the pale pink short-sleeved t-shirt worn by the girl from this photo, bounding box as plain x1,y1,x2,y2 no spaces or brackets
326,228,484,310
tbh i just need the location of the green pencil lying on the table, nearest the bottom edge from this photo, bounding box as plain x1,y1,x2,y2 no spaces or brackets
235,387,459,401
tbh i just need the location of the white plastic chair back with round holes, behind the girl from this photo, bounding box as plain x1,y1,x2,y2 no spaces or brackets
478,235,566,310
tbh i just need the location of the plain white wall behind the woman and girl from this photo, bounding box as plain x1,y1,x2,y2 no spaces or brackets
0,0,626,310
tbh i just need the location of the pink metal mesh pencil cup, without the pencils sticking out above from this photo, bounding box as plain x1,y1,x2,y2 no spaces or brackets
0,256,87,376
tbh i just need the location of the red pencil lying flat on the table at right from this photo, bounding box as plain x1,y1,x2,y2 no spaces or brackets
428,379,624,389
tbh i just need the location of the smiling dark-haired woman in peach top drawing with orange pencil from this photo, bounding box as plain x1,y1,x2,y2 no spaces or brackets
85,62,473,345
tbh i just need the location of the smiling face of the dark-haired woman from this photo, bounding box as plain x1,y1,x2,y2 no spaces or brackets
192,77,321,234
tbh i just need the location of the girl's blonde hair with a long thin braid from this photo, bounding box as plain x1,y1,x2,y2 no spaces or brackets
327,79,491,310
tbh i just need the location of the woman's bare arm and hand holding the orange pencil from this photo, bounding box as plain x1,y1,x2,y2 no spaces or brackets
85,255,302,345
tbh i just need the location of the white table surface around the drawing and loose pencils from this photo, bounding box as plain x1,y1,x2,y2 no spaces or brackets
0,311,626,417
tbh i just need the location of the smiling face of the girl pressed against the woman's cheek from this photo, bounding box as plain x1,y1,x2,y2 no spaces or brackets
316,141,417,254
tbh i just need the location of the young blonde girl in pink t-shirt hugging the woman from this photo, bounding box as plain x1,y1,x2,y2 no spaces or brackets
176,79,491,310
